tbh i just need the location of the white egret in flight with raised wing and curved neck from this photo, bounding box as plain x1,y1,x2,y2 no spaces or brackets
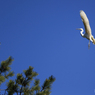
77,10,95,47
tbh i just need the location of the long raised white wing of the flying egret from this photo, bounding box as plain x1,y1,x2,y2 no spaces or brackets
80,10,91,35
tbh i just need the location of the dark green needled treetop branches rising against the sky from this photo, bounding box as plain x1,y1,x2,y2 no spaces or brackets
0,57,55,95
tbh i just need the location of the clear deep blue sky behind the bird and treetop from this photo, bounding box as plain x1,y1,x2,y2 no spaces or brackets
0,0,95,95
